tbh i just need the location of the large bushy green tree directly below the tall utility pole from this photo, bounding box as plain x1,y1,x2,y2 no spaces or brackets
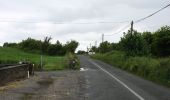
120,31,148,56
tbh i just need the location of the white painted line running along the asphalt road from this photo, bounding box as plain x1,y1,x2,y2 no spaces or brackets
89,60,145,100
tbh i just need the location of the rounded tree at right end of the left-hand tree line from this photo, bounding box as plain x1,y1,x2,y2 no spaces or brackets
65,40,79,53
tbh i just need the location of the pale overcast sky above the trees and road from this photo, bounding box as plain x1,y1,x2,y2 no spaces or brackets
0,0,170,50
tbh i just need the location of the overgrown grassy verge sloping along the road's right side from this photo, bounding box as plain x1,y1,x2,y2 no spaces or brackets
92,51,170,87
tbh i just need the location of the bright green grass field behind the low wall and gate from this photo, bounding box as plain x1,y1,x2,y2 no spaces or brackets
0,47,66,70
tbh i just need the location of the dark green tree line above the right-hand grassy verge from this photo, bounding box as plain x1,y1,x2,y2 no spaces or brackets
90,26,170,57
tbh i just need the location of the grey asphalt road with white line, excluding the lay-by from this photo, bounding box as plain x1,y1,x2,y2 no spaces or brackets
79,56,170,100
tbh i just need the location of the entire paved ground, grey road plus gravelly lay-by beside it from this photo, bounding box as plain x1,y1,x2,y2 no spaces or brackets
0,56,170,100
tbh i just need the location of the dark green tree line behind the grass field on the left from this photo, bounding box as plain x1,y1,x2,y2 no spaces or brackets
3,37,79,56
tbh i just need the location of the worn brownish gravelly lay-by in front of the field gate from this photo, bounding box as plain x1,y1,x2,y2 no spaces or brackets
0,70,86,100
